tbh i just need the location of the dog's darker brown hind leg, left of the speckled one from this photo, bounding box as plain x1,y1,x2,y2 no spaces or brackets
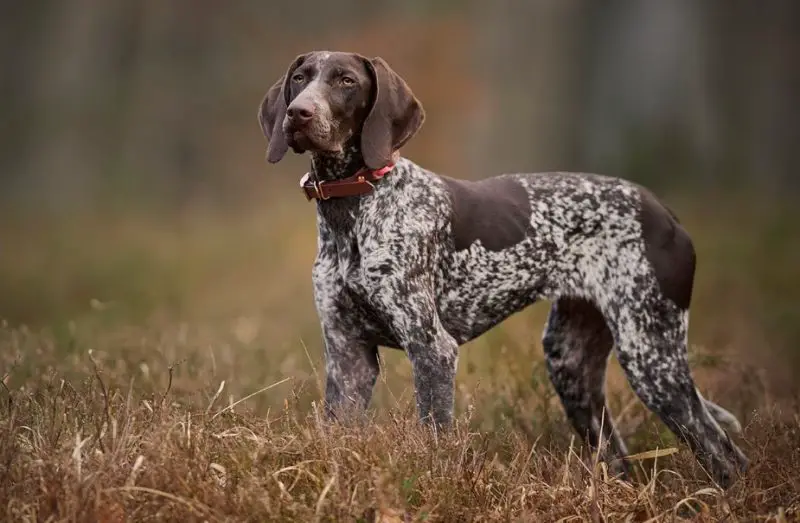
542,298,628,475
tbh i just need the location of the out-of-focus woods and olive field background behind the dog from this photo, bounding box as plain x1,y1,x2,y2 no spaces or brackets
0,0,800,400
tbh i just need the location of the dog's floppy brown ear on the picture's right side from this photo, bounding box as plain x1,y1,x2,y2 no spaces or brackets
361,58,425,169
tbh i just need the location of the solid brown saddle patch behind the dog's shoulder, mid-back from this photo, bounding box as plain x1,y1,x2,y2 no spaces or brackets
442,176,531,251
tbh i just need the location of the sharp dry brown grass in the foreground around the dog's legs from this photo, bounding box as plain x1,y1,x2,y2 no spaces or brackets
0,327,800,522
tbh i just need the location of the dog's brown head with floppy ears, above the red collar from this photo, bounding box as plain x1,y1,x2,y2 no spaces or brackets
258,51,425,169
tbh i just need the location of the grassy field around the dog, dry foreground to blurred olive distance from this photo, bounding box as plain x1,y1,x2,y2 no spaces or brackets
0,199,800,522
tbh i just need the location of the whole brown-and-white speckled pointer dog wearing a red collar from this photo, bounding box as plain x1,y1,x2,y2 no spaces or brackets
259,52,748,487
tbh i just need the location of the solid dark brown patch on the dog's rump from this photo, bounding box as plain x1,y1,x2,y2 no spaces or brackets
639,188,696,310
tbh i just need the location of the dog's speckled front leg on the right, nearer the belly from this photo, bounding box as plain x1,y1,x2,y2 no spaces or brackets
374,276,458,427
